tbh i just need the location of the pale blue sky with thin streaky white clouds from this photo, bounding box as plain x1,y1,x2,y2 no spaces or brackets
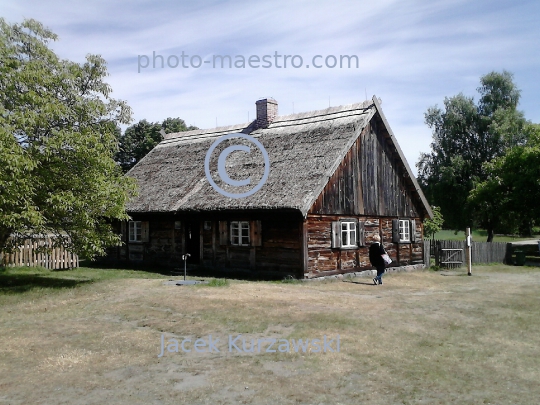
0,0,540,174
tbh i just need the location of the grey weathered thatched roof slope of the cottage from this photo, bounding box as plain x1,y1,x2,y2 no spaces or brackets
127,98,429,215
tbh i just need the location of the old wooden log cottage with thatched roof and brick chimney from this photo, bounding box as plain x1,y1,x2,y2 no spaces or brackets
117,97,432,278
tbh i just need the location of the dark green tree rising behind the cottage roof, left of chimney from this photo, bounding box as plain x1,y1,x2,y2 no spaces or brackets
115,118,197,172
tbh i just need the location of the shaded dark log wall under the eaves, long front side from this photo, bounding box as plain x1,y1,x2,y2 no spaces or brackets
114,211,303,277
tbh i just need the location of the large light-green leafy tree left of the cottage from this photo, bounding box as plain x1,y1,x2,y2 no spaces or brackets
0,19,135,258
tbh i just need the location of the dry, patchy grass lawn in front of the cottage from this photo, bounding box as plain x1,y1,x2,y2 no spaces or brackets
0,265,540,405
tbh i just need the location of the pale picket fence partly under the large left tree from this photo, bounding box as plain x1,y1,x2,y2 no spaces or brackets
0,236,79,269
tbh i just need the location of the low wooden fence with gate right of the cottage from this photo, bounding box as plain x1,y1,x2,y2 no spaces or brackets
424,240,506,268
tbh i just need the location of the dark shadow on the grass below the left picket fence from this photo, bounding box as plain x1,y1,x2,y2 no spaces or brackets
0,272,92,294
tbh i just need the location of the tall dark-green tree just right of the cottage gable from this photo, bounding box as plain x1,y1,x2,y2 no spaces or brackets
417,71,526,241
